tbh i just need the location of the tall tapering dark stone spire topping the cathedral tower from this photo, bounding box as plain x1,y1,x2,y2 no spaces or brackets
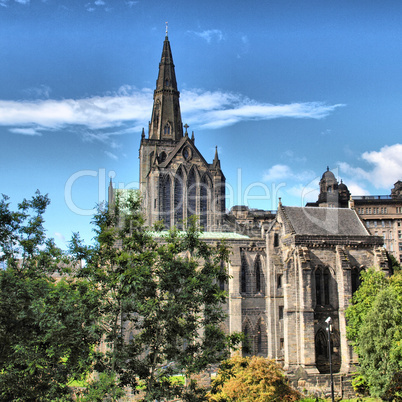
149,30,183,141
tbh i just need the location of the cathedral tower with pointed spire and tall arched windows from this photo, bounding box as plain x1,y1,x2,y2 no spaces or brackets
139,33,225,231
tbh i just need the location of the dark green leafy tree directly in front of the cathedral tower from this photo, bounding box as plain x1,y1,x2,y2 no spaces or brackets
71,193,239,400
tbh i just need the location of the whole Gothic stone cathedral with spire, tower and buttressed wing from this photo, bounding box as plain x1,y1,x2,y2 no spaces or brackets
109,34,388,393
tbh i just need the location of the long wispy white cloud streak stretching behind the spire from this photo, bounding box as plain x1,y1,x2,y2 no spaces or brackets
0,86,342,144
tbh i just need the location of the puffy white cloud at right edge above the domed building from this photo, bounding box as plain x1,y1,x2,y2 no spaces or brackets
339,144,402,188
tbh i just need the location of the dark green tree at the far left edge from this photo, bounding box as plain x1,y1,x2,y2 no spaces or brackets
0,192,99,401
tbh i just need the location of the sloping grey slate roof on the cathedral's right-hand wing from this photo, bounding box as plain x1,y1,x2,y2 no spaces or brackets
282,207,370,236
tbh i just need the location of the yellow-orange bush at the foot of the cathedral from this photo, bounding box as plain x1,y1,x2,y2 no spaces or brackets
208,356,300,402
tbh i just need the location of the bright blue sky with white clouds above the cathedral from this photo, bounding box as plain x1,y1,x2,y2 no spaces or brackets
0,0,402,247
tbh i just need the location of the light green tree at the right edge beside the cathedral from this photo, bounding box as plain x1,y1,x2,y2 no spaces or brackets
346,269,402,400
